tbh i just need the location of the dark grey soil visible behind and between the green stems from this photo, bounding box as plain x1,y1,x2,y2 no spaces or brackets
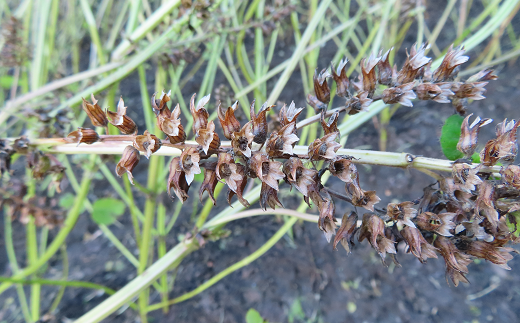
0,1,520,323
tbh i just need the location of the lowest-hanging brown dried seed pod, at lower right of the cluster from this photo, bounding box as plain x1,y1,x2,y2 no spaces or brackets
433,236,471,286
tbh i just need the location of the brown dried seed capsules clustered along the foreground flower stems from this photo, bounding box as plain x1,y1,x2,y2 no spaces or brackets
68,45,520,285
